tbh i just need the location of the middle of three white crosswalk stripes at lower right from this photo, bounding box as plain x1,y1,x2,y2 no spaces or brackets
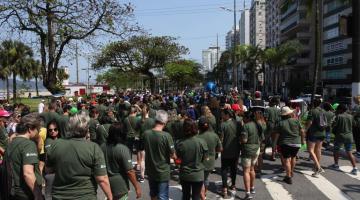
300,170,351,200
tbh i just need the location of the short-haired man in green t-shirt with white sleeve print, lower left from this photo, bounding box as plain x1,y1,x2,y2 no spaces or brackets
5,113,43,200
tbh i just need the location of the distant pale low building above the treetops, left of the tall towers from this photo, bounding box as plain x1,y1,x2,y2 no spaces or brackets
202,46,222,73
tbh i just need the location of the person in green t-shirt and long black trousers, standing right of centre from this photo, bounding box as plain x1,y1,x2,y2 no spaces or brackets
219,109,240,198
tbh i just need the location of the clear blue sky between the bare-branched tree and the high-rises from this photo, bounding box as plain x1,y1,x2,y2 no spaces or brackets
131,0,250,63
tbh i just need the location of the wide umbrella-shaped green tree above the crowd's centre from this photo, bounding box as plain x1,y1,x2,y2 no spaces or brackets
93,35,188,92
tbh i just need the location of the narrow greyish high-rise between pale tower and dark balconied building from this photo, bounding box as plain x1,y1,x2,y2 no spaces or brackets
266,0,280,47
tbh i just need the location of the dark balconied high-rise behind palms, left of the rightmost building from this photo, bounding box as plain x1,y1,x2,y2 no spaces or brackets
279,0,315,95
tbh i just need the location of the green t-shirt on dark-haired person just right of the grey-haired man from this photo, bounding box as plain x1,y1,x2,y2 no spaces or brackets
176,136,208,182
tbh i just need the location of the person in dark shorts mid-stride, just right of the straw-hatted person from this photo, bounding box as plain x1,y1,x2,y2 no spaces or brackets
306,99,325,177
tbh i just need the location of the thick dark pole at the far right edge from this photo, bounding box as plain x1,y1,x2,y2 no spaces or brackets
351,0,360,103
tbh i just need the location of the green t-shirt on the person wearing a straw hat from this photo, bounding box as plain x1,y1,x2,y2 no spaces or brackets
277,118,301,145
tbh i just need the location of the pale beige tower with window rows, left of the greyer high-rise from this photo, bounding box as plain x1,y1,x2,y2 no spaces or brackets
250,0,266,48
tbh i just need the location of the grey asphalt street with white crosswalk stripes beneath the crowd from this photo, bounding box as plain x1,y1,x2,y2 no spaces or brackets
46,150,360,200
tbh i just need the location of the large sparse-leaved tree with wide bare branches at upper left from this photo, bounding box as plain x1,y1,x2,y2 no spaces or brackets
0,0,138,93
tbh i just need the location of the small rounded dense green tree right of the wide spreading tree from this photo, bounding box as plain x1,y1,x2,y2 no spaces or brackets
165,60,203,89
